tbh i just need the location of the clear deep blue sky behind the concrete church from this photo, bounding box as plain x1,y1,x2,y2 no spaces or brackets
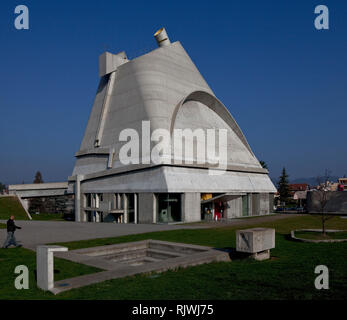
0,0,347,183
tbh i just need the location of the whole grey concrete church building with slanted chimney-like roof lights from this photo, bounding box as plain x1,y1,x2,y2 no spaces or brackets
68,28,276,223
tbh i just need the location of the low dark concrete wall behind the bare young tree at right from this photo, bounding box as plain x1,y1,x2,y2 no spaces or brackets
307,191,347,213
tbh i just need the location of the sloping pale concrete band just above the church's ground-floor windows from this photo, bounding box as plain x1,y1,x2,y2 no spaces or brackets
77,165,273,193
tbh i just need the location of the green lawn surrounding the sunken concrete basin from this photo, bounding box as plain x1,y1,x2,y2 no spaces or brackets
0,216,347,300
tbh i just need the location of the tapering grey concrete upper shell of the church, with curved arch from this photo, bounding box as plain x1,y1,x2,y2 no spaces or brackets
73,37,268,181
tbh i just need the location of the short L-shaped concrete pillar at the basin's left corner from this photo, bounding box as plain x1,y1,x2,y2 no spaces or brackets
36,246,68,291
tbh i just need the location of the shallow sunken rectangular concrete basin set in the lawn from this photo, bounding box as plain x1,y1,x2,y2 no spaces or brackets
50,240,230,294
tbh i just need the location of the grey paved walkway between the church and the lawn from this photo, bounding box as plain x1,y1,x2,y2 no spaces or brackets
0,220,206,249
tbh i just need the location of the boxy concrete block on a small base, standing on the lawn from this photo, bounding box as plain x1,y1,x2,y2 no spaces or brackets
236,228,275,260
